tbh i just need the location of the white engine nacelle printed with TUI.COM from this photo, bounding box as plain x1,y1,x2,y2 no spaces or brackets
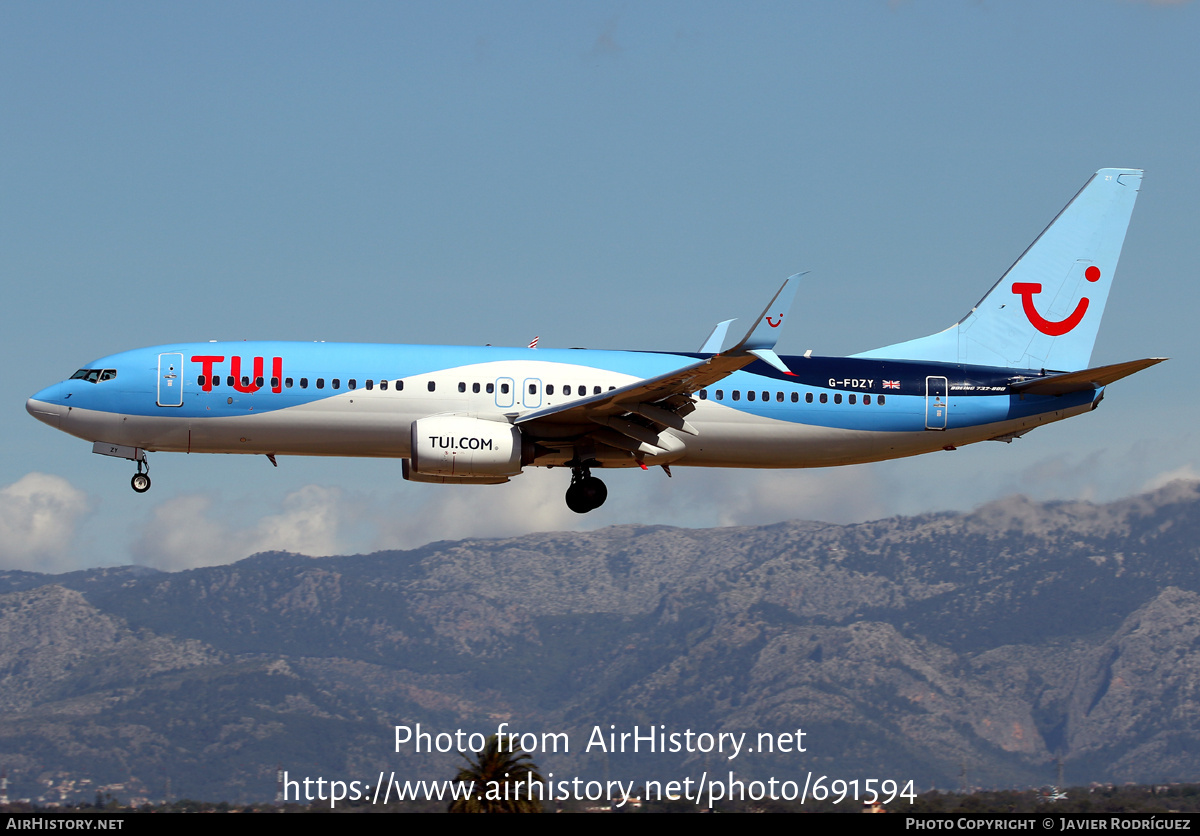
412,415,522,479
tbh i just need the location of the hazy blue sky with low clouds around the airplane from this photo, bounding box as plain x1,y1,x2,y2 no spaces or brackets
0,0,1200,571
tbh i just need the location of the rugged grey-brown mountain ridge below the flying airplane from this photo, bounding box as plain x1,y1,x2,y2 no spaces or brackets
0,482,1200,800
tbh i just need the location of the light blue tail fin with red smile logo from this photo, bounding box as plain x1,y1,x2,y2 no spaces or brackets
854,168,1141,371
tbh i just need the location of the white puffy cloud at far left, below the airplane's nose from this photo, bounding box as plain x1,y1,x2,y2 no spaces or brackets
0,473,89,572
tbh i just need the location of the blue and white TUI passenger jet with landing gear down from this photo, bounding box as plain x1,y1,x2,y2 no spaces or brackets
26,168,1165,513
